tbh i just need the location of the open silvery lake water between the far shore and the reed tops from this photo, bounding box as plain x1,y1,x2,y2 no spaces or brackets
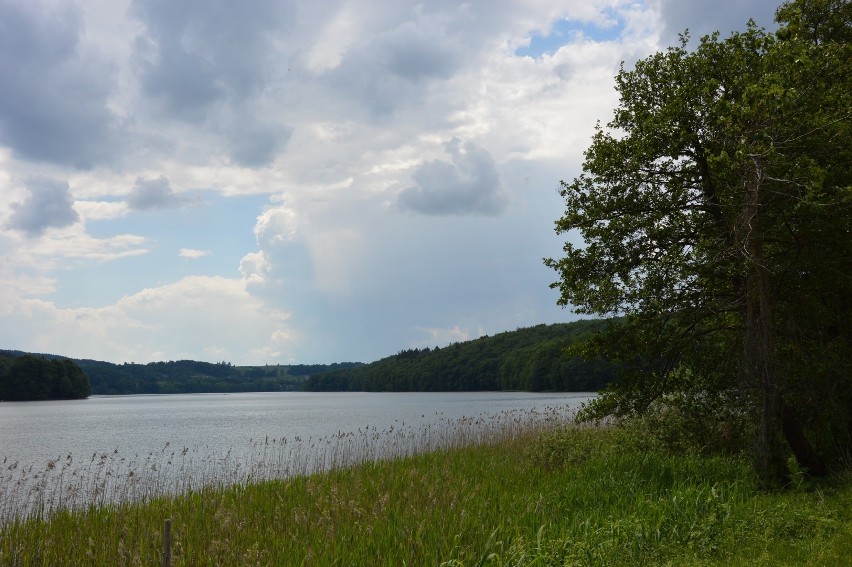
0,392,592,466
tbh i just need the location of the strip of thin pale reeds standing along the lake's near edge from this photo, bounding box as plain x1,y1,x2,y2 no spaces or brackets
0,407,575,525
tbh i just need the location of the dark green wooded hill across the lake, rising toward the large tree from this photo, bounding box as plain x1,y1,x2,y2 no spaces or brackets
304,320,615,392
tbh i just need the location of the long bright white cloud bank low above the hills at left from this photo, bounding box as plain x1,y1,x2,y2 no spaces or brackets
0,276,297,364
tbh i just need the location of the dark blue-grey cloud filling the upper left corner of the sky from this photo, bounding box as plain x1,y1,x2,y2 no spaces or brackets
0,1,116,167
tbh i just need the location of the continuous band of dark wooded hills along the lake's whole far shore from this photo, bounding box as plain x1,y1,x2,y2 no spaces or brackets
0,321,615,399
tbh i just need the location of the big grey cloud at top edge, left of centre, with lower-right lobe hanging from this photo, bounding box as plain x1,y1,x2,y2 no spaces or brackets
131,0,291,167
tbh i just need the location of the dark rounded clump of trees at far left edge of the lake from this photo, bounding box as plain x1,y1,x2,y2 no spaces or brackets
0,352,92,401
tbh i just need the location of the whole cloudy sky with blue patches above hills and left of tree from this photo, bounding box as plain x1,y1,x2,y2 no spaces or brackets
0,0,778,365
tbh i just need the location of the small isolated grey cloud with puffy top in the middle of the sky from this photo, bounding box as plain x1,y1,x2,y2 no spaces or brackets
398,139,506,215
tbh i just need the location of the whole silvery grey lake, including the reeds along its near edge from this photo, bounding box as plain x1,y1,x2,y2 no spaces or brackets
0,392,595,519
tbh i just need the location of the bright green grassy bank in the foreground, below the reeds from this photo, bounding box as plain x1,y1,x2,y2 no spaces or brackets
0,414,852,567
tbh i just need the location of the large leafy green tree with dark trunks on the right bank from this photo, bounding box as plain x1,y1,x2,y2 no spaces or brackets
545,0,852,484
